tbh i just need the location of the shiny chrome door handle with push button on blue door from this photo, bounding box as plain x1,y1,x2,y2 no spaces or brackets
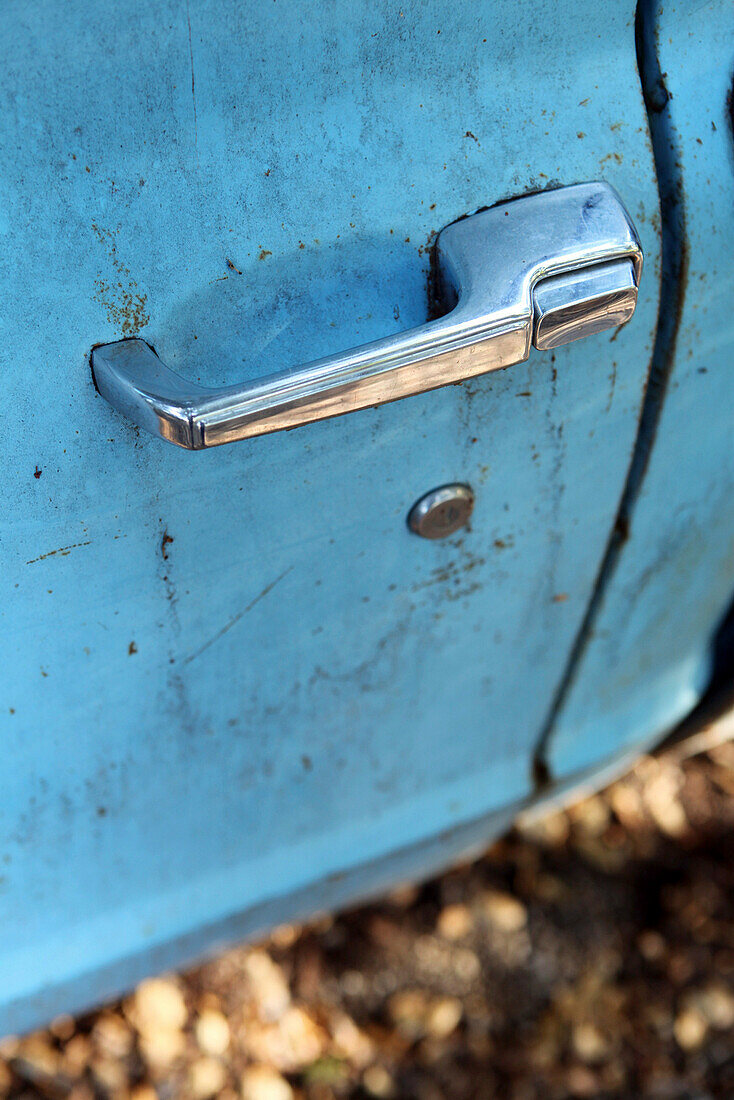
91,183,643,450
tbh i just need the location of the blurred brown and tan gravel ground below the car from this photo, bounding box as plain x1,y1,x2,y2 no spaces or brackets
0,735,734,1100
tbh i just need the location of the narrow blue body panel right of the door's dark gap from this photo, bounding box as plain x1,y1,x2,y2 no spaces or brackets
548,0,734,777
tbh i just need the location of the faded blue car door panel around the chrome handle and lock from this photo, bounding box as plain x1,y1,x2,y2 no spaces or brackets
0,0,659,1032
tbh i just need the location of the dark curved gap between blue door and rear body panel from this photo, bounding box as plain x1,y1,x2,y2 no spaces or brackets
533,0,688,791
